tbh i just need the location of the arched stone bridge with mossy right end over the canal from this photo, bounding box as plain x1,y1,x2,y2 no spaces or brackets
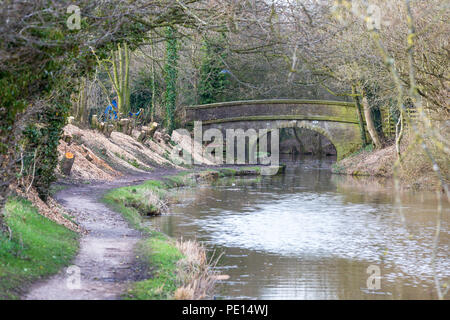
185,99,362,160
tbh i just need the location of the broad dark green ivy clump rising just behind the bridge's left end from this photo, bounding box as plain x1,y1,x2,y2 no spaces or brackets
198,41,229,104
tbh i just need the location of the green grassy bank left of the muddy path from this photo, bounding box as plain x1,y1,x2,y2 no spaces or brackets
0,198,78,299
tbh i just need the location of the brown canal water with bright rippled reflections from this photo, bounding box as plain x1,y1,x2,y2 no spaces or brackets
152,159,450,299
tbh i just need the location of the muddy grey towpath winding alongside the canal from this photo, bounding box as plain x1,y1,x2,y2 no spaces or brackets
23,168,177,300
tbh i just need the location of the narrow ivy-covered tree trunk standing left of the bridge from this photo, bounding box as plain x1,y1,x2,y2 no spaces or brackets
164,27,178,134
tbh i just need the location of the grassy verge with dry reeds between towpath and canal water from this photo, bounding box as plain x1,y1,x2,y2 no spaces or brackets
103,167,260,300
